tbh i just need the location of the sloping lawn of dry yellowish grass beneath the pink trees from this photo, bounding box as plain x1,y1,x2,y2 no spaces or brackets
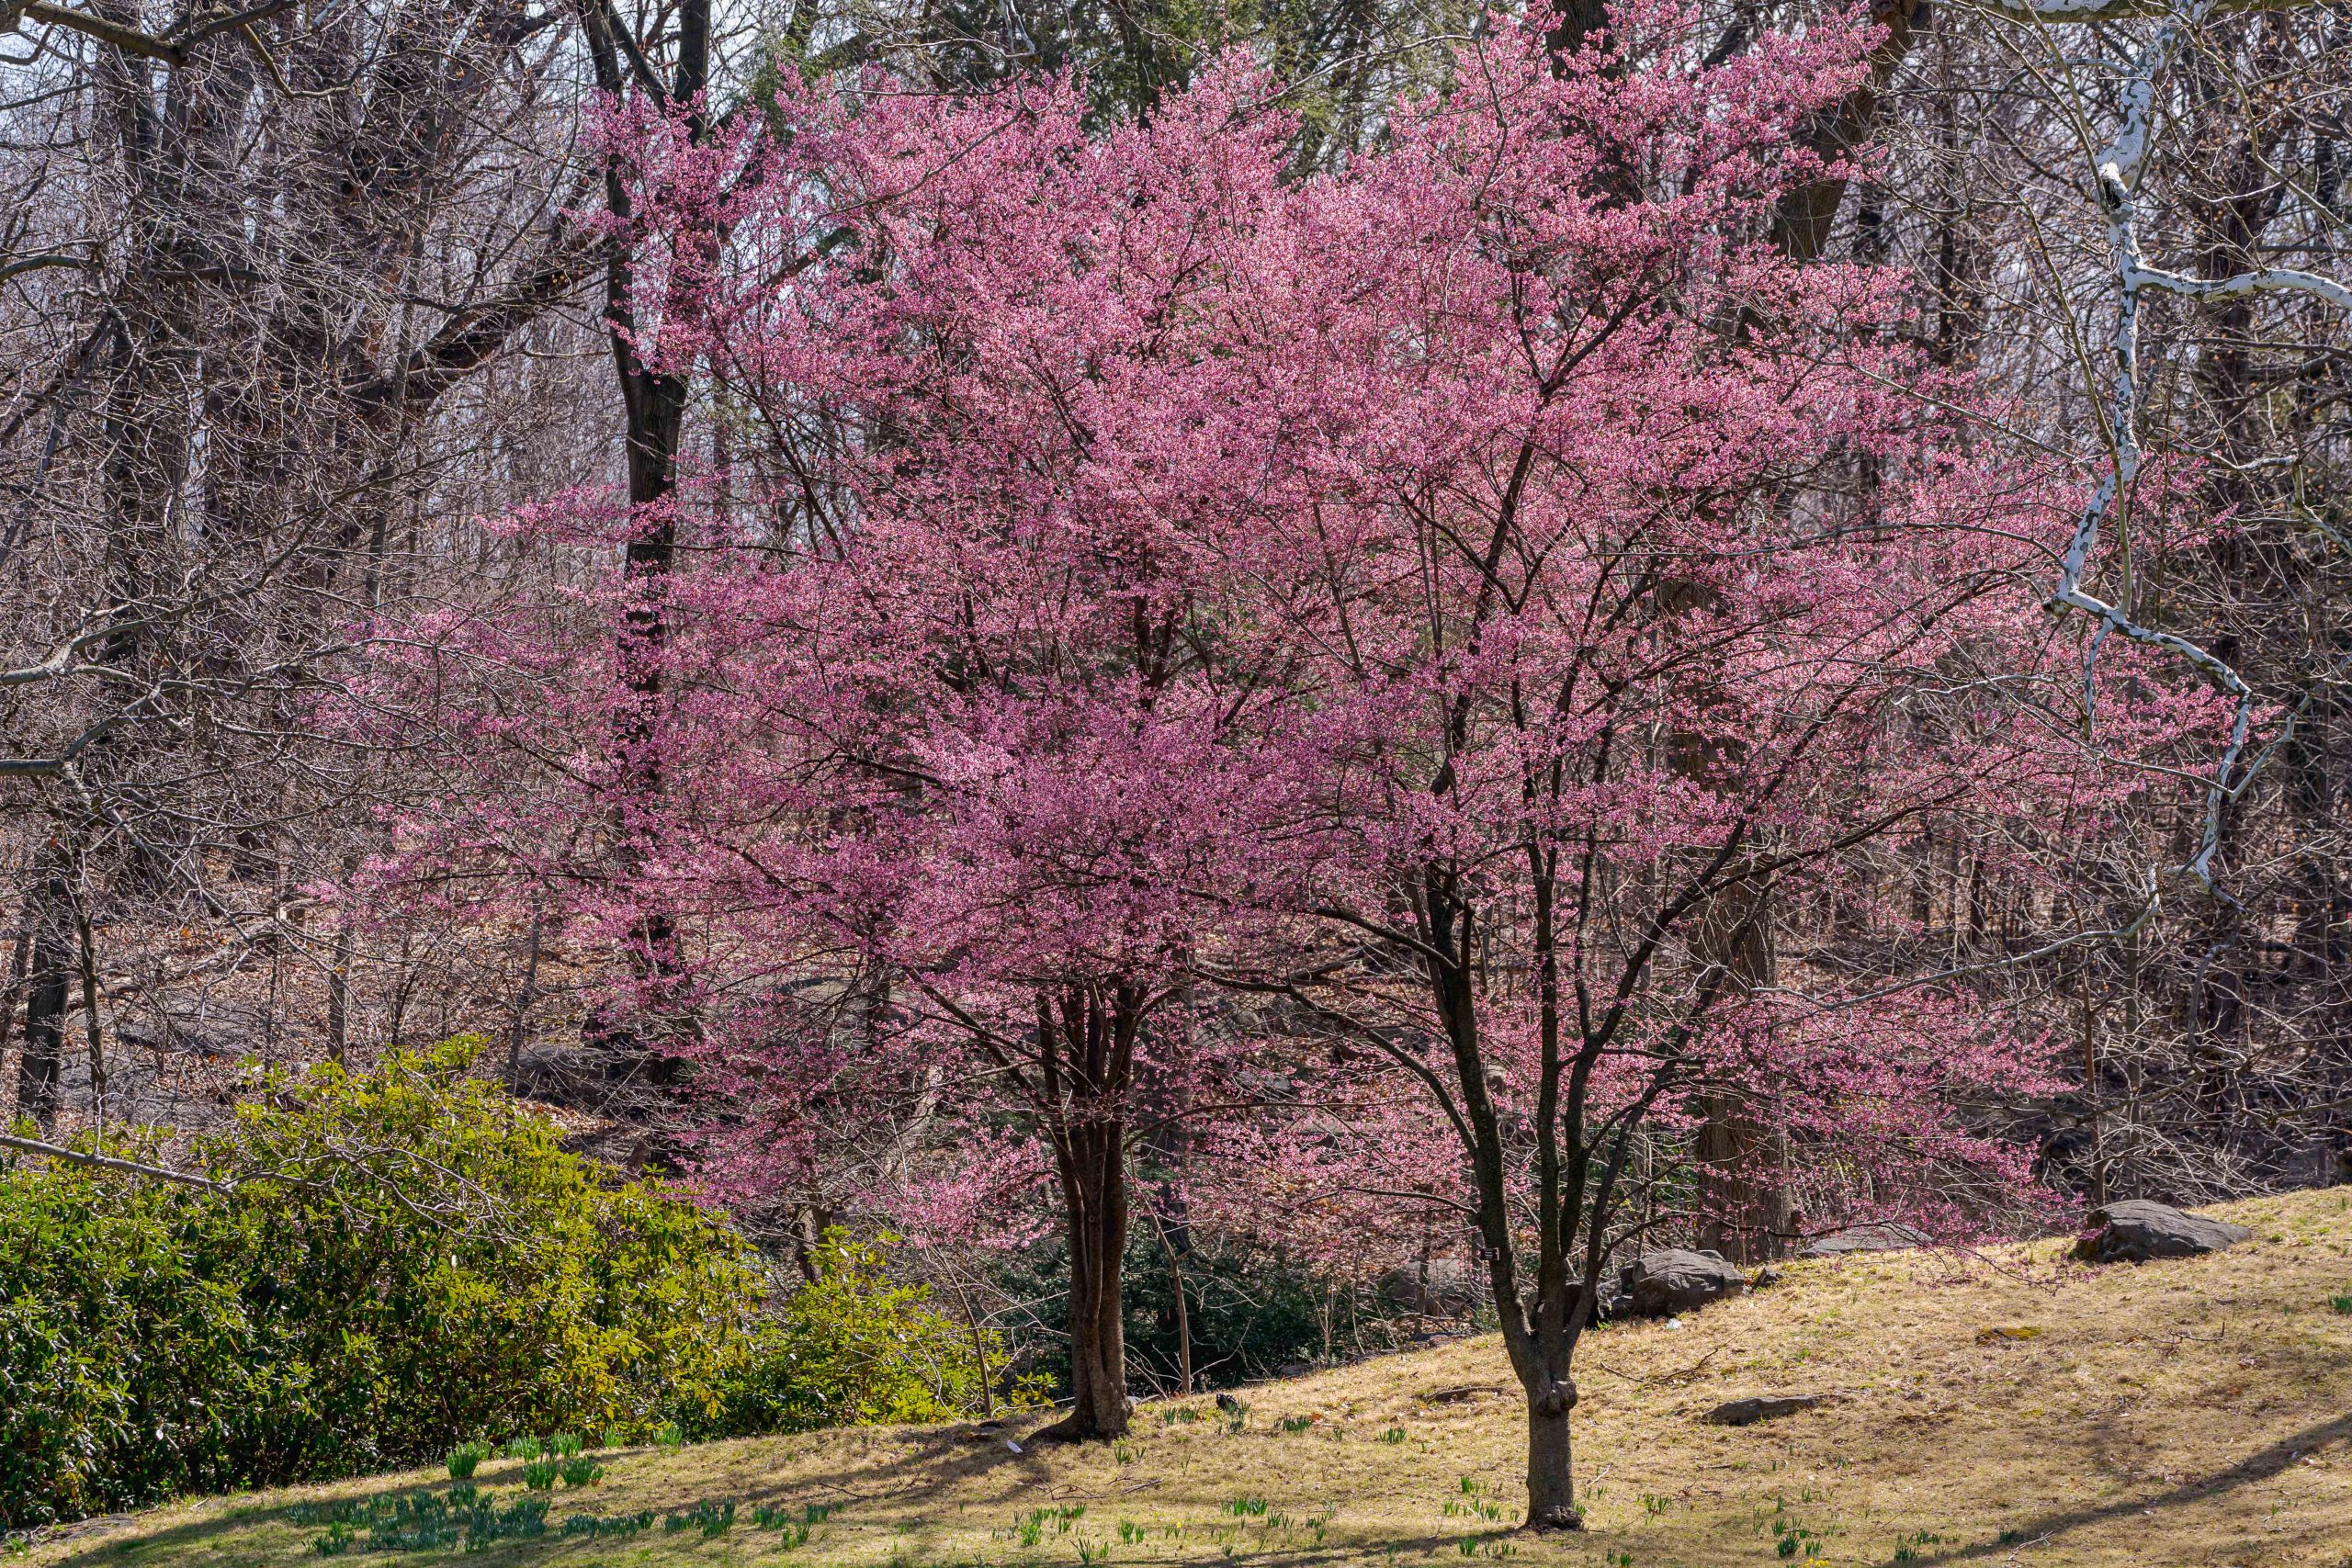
28,1190,2352,1568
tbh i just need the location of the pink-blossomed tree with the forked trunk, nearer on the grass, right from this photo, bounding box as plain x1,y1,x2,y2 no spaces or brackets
1128,7,2173,1530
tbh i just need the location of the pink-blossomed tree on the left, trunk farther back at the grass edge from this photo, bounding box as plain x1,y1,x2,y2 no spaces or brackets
362,77,1345,1438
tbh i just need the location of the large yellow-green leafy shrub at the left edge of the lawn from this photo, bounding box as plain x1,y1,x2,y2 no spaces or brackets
0,1042,762,1550
